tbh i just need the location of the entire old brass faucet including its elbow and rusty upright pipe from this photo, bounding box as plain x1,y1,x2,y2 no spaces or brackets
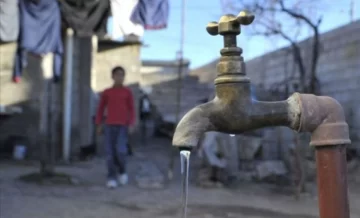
173,11,351,218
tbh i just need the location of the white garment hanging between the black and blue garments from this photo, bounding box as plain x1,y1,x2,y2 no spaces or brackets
110,0,144,40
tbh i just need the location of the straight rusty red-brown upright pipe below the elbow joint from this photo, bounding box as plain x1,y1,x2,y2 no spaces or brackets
316,145,350,218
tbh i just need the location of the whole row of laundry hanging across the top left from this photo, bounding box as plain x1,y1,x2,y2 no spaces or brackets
0,0,169,82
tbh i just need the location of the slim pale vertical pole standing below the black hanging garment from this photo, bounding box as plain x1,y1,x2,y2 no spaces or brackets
62,28,74,162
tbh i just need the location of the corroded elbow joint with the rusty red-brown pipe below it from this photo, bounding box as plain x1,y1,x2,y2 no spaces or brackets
298,94,351,218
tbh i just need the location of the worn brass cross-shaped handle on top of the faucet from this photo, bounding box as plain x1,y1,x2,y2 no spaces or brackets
206,11,255,36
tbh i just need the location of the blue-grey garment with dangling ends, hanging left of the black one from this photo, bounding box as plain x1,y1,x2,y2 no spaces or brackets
13,0,63,82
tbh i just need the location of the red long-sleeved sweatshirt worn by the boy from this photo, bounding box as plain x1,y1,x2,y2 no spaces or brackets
95,87,135,126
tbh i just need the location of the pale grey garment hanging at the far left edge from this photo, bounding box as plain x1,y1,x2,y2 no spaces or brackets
0,0,19,42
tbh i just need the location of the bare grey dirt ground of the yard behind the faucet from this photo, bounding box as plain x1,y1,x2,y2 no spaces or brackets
0,139,360,218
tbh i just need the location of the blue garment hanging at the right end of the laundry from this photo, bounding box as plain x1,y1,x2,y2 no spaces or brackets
131,0,169,30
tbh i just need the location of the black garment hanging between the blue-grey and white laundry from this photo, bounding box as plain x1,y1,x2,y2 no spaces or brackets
59,0,110,36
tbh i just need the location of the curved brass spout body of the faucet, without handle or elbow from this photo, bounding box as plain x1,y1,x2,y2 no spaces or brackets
173,93,300,148
